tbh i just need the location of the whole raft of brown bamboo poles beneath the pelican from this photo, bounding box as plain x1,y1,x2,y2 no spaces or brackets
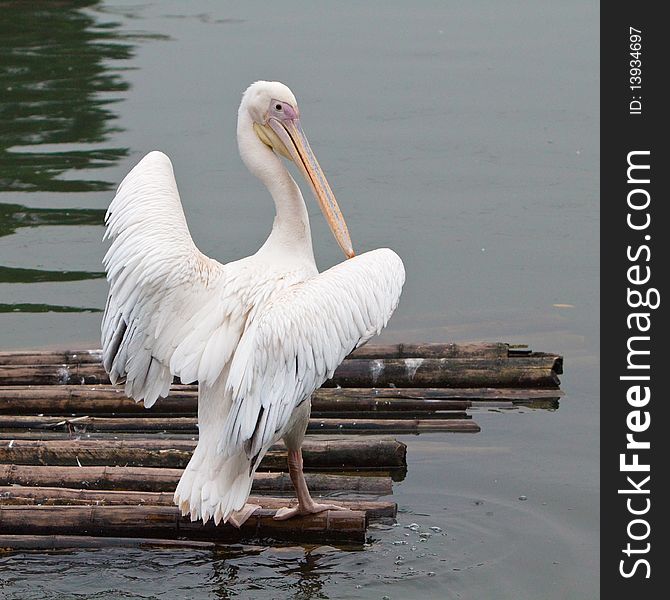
0,343,563,549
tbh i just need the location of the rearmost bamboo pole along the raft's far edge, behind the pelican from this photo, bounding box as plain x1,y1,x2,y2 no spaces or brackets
0,342,509,365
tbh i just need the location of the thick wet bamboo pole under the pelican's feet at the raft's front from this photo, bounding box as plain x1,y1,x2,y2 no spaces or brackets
0,506,366,543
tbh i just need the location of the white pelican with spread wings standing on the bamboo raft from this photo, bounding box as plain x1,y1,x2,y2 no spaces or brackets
101,81,405,527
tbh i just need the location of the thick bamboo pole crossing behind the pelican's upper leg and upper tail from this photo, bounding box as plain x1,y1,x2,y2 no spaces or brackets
0,438,407,471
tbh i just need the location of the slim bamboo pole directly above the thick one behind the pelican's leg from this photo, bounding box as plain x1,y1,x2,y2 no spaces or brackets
0,413,479,434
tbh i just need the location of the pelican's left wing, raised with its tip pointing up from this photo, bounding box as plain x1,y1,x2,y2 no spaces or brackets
102,152,251,407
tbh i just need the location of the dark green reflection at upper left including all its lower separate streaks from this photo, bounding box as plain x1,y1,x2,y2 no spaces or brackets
0,0,138,313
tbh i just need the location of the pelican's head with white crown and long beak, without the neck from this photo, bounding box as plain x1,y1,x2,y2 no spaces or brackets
242,81,354,258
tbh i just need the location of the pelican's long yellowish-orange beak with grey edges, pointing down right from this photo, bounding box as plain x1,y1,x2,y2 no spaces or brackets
256,112,355,258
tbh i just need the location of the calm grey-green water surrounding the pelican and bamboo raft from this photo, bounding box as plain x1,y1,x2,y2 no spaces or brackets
0,0,599,600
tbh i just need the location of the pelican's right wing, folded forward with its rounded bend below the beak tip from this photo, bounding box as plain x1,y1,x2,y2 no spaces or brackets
219,249,405,458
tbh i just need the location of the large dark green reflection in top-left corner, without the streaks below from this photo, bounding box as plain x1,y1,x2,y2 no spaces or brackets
0,0,133,192
